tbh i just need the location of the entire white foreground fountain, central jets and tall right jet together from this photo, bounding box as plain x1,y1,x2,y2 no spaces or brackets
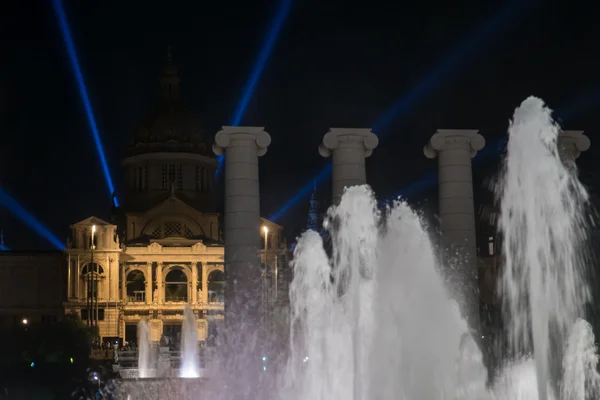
280,98,600,400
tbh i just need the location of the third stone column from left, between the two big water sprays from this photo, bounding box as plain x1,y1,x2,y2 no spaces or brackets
424,129,485,331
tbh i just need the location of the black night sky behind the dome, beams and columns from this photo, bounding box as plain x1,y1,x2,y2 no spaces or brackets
0,0,600,249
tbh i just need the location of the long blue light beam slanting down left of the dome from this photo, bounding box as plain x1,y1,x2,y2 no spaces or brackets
52,0,119,207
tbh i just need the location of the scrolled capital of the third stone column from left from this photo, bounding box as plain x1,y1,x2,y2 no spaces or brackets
423,129,485,158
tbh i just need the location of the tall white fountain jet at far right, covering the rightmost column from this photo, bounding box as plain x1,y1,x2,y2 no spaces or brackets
498,97,594,400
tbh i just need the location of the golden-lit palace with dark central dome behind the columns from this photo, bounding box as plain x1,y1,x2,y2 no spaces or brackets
0,50,289,342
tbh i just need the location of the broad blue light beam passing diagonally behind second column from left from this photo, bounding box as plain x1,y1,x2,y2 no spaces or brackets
270,0,531,222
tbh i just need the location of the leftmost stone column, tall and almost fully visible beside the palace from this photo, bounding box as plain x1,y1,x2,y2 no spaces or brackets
213,126,271,399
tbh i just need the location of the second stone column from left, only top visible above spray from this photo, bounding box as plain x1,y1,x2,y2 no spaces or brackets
319,128,379,204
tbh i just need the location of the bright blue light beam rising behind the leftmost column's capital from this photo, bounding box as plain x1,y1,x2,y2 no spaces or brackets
216,0,292,177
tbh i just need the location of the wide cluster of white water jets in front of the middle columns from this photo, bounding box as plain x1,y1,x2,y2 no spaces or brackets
285,186,487,400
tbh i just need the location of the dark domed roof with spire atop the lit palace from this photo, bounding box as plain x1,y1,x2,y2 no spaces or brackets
132,50,210,154
